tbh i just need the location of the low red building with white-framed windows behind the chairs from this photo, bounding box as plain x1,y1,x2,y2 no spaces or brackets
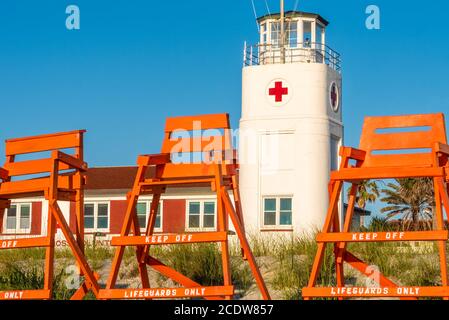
0,167,216,245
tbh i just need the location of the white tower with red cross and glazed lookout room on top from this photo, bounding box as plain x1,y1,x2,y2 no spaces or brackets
239,1,343,233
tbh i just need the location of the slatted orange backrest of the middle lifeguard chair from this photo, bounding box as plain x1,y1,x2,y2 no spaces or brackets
162,113,233,164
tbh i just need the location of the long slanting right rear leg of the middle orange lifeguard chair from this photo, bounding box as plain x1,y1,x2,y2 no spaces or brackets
221,187,271,300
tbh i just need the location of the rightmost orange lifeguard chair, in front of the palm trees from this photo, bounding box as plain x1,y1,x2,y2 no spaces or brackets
302,113,449,299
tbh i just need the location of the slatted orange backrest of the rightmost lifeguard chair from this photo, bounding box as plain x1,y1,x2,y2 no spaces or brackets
360,113,447,167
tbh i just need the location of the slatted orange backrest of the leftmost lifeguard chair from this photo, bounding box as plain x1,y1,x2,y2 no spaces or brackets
4,130,86,177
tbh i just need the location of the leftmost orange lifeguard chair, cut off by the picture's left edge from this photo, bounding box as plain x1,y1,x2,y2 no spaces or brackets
0,130,98,300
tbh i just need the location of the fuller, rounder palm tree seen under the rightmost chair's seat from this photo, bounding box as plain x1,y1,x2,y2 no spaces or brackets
380,178,435,230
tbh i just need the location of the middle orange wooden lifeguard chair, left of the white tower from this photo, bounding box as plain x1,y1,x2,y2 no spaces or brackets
98,114,270,299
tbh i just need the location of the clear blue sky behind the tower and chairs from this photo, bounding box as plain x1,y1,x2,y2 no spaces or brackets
0,0,449,172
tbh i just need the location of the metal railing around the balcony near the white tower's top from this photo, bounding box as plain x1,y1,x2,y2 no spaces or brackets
243,43,341,72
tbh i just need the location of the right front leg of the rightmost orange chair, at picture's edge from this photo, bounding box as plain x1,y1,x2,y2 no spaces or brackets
433,177,449,300
